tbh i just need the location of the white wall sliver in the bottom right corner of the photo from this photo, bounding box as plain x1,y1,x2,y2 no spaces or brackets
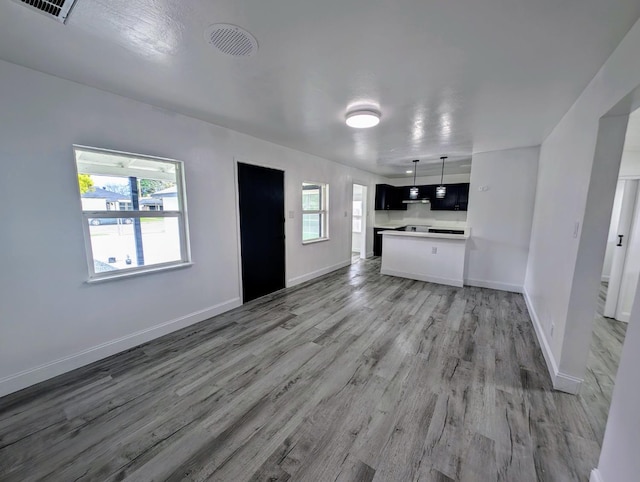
596,274,640,482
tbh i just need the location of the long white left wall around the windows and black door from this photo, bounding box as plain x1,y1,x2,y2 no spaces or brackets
0,61,382,395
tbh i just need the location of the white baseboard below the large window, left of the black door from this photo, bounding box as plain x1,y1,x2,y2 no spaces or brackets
0,298,242,397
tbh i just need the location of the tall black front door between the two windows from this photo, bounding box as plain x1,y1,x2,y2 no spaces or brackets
238,163,285,303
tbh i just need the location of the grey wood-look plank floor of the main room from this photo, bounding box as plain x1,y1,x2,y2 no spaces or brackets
0,259,599,482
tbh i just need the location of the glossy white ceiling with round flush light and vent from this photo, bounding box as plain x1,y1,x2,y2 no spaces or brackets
0,0,640,176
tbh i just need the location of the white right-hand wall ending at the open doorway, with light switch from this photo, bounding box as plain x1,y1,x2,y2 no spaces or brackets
525,16,640,391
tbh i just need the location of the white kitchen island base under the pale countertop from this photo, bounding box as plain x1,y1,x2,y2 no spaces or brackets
380,231,469,286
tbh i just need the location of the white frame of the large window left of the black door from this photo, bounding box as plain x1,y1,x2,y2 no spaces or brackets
73,144,193,283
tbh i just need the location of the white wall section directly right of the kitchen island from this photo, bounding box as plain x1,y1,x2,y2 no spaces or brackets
465,147,539,292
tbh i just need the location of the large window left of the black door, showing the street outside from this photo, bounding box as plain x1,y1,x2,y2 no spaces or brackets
74,146,190,281
